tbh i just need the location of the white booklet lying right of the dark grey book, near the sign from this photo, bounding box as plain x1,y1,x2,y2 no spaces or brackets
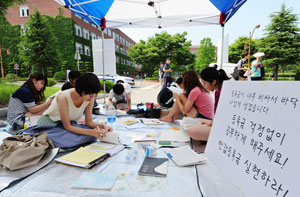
164,145,206,167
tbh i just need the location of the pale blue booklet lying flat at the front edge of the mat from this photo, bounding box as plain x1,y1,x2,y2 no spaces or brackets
71,172,118,190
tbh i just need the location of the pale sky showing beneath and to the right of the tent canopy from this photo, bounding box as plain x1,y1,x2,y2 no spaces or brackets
120,0,300,45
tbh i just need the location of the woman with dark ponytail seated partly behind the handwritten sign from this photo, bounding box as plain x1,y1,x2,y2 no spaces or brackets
188,67,230,141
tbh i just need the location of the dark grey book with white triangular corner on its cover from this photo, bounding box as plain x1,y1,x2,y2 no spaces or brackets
138,157,169,177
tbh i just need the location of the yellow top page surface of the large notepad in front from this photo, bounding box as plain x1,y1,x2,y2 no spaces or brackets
60,147,105,165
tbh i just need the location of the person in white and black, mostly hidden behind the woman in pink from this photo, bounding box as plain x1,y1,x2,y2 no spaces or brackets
157,77,183,108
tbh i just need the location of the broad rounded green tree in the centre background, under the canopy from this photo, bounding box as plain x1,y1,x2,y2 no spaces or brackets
128,32,194,74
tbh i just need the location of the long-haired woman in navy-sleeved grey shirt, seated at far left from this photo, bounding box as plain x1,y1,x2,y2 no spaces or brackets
7,73,53,130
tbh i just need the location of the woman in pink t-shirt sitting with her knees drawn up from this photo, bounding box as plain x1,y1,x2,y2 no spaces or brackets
160,70,214,122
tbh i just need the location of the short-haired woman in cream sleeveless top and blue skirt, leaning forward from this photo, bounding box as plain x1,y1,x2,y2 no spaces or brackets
23,73,112,148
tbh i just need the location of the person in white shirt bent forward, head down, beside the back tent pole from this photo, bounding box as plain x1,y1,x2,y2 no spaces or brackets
106,82,131,111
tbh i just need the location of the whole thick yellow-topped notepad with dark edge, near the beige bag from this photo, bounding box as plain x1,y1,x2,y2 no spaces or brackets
55,147,109,168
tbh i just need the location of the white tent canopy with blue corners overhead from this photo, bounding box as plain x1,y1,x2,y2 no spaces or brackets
56,0,246,28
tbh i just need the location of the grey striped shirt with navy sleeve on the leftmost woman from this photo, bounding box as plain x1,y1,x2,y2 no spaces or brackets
7,86,36,125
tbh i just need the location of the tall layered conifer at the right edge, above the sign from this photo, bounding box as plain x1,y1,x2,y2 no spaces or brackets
259,4,300,78
